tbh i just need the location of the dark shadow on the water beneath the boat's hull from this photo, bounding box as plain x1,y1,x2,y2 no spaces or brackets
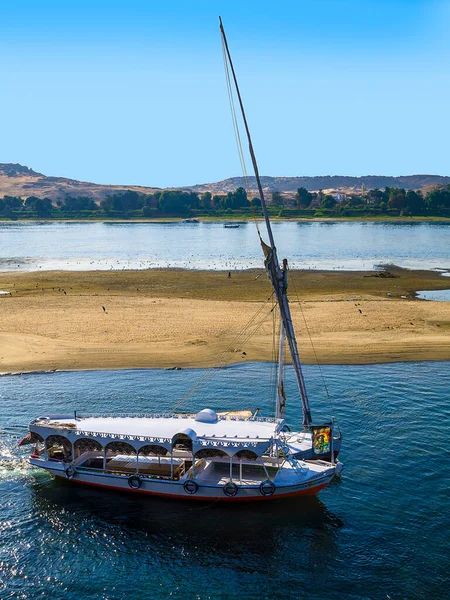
32,478,344,557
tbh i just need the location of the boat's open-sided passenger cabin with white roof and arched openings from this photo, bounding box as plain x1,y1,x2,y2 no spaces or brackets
30,409,284,484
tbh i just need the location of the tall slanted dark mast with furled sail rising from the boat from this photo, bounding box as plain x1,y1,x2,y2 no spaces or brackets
219,17,312,427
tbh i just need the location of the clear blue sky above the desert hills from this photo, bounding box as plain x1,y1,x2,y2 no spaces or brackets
0,0,450,187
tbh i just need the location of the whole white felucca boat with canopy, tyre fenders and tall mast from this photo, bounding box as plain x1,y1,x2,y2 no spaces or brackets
20,21,343,502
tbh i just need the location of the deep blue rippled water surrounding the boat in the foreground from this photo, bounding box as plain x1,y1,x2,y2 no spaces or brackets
0,362,450,600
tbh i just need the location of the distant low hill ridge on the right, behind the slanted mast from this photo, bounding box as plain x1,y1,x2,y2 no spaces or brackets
186,175,450,194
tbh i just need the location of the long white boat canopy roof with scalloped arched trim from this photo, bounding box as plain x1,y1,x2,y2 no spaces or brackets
30,409,284,456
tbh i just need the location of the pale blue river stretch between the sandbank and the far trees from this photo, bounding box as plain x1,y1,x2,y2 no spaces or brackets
0,222,450,271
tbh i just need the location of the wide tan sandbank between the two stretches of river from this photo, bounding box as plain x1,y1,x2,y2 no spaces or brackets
0,269,450,373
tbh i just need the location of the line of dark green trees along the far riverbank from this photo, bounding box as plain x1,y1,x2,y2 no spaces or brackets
0,185,450,220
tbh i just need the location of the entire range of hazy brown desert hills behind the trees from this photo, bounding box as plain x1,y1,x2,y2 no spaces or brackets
0,163,450,201
